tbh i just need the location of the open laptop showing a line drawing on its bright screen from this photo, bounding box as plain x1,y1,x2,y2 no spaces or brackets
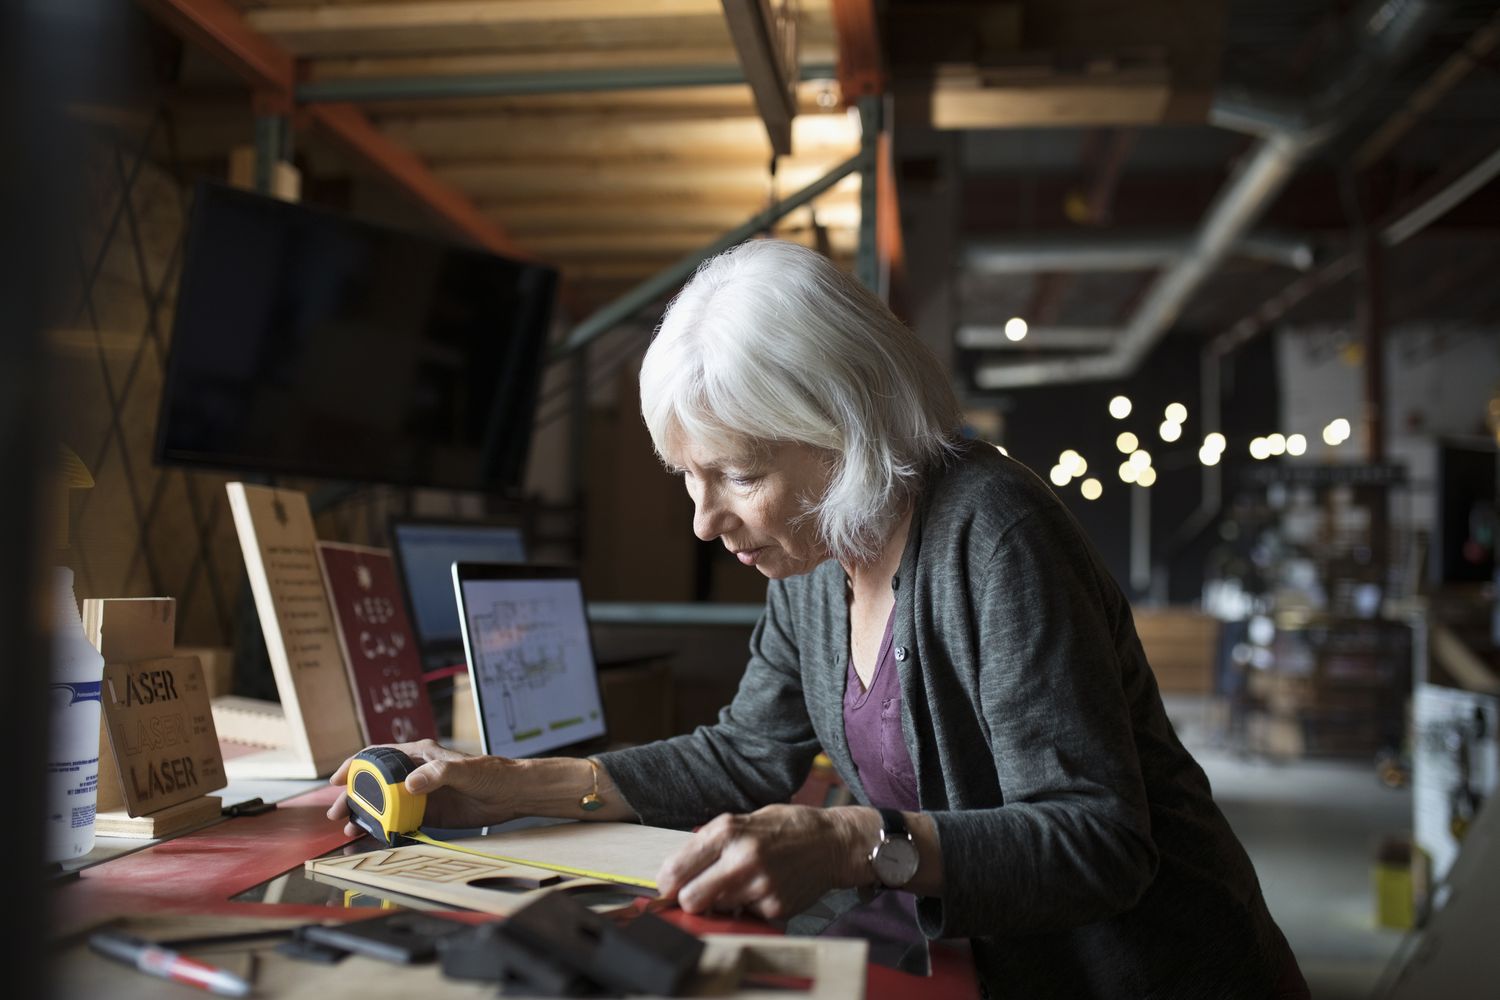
452,562,606,757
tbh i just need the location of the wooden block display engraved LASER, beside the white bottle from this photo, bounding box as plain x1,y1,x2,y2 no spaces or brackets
83,597,225,840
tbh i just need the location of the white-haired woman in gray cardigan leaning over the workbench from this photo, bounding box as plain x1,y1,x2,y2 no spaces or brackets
330,241,1298,997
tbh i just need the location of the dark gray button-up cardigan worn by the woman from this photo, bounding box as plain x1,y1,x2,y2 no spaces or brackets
599,445,1283,997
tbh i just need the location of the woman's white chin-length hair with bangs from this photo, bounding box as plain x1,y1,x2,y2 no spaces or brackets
641,240,962,564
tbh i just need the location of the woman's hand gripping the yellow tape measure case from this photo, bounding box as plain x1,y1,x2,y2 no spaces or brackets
329,739,518,837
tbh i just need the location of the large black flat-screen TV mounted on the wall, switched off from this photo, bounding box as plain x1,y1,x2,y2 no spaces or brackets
156,184,557,492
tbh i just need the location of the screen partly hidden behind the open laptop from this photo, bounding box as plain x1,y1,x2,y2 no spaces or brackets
390,517,527,670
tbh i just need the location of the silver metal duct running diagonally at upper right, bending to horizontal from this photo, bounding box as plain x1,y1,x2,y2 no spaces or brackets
975,0,1443,390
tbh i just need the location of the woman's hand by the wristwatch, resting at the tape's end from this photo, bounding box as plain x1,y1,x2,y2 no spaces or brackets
657,805,879,921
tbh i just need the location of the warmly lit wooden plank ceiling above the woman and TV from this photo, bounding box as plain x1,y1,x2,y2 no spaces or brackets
217,0,860,313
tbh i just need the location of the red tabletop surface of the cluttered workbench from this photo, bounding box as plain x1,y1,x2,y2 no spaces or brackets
54,787,980,1000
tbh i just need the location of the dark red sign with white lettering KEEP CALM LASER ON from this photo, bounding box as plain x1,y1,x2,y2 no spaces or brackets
318,541,438,744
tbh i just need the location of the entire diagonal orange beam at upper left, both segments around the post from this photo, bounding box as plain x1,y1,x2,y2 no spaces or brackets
140,0,527,256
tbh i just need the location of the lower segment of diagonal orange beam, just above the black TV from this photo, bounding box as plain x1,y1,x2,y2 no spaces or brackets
303,102,530,256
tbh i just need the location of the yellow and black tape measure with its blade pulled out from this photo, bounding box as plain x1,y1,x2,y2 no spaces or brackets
347,747,657,889
